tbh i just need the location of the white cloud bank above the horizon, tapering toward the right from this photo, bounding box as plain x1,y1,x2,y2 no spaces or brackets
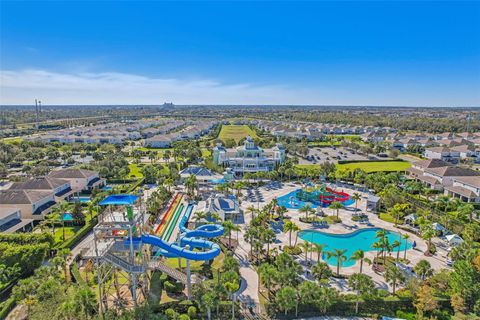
0,70,313,104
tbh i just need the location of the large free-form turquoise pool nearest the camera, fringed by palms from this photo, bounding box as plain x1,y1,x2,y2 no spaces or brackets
299,228,412,267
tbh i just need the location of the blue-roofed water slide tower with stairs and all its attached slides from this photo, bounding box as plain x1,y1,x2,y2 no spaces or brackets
82,193,224,313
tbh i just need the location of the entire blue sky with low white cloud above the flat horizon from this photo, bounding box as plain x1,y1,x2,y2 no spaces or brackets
0,1,480,106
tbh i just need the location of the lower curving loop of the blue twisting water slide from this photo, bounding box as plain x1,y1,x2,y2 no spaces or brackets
141,235,220,261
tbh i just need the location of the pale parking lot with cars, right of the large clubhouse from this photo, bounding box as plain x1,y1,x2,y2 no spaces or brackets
299,147,372,164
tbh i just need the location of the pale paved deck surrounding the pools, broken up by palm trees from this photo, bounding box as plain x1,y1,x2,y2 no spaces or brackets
239,183,448,296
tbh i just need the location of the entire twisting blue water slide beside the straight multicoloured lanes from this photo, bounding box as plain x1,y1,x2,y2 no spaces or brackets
141,204,224,261
